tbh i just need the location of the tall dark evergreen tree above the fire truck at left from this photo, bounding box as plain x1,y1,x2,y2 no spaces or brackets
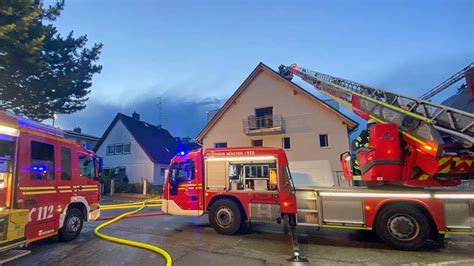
0,0,102,120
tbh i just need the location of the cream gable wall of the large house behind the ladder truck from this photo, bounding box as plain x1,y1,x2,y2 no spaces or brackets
202,71,349,171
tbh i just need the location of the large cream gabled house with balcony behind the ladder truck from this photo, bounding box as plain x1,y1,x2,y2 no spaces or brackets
196,63,358,185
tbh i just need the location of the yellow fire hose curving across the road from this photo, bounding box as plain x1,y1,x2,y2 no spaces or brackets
94,200,173,266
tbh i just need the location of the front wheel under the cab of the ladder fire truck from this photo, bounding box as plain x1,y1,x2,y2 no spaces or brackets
209,199,242,235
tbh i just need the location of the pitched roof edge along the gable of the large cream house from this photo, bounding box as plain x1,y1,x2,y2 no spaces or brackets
196,62,359,142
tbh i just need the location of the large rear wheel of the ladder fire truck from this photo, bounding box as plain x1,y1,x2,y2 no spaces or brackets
375,205,431,250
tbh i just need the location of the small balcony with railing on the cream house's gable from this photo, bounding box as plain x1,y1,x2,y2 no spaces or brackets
243,115,285,136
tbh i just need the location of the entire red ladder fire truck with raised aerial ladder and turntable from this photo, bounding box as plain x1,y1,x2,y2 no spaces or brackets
162,62,474,254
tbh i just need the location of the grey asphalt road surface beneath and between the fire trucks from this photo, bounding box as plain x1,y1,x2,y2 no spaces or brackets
10,208,474,266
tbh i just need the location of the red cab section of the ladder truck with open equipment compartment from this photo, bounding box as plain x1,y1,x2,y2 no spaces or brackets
162,148,296,234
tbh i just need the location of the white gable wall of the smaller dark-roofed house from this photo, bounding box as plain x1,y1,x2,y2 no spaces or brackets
97,120,155,183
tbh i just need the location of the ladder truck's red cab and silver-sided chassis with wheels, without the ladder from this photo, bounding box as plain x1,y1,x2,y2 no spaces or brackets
162,147,474,250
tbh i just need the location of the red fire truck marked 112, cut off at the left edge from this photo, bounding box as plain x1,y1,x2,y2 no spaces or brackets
0,111,100,263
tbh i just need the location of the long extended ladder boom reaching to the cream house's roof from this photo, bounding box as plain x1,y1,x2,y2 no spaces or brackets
279,64,474,148
